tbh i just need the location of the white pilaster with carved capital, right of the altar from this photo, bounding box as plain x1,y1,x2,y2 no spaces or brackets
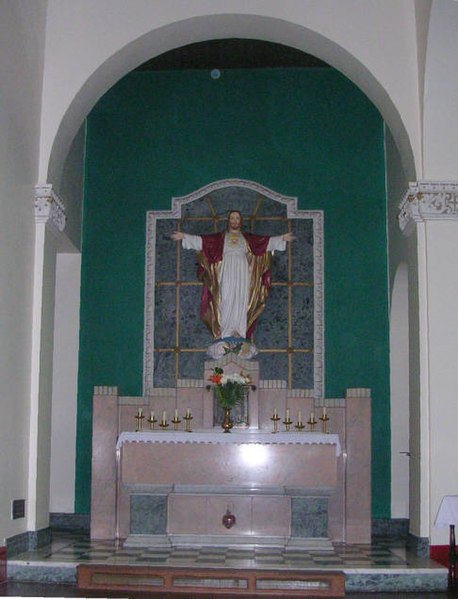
398,181,458,544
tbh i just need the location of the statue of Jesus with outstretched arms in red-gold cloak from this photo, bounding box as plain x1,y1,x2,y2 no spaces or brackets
171,210,295,339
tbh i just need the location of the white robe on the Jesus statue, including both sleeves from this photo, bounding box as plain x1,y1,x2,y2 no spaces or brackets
182,232,286,339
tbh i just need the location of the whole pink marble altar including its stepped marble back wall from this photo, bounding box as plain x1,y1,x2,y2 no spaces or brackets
91,356,371,549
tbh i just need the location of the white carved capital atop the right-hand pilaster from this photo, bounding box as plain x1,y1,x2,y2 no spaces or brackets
398,181,458,235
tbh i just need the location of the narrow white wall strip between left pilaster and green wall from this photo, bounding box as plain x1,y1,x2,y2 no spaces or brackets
50,254,81,513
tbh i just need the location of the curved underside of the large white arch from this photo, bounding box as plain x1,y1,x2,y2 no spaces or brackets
48,15,416,188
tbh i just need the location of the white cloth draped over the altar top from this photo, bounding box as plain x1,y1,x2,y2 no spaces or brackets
116,430,342,456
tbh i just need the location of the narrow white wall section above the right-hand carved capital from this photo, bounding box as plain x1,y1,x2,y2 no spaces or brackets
423,0,458,180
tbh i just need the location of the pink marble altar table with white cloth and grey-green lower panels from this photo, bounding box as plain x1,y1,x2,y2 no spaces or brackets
117,431,340,546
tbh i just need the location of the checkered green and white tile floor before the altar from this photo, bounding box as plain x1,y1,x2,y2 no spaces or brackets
13,533,439,570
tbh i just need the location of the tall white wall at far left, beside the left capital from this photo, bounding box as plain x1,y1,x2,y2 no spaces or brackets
0,0,46,545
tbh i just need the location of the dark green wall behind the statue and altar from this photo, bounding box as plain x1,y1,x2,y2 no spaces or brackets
75,68,390,518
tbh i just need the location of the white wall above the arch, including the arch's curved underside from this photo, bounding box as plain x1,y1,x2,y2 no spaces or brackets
40,0,421,186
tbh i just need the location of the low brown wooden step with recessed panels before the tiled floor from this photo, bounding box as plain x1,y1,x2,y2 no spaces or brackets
77,564,345,597
